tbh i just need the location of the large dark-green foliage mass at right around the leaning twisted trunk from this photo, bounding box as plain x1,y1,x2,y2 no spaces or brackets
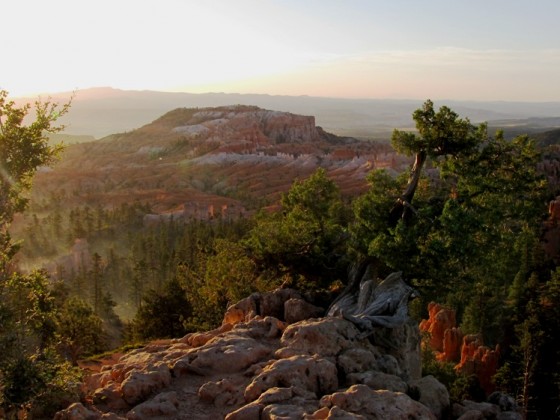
351,102,546,343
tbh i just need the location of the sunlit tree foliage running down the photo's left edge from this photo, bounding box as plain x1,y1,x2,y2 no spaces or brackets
0,90,83,417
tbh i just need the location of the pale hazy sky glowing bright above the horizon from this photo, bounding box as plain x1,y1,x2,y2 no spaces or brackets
4,0,560,101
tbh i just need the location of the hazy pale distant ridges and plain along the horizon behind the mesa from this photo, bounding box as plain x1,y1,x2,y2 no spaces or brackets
15,88,560,140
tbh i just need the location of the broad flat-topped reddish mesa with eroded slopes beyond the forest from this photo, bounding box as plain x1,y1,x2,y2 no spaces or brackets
30,105,409,214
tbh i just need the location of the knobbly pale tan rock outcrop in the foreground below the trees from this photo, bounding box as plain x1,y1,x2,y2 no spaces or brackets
55,280,520,420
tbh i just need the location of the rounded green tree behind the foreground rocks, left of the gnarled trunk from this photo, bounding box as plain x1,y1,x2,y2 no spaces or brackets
245,169,347,287
